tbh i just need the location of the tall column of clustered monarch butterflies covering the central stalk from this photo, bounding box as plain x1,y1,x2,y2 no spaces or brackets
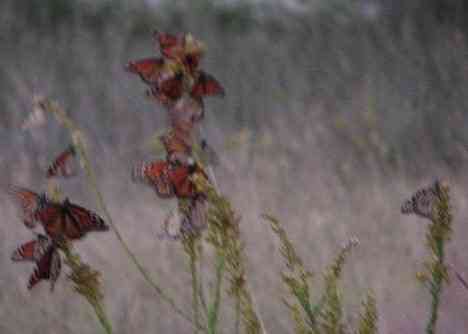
126,31,225,239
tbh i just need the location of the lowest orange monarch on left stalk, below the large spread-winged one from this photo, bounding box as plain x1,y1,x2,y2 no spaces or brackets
11,234,62,290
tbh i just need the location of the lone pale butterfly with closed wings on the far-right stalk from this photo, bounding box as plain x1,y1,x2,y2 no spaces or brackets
401,181,441,219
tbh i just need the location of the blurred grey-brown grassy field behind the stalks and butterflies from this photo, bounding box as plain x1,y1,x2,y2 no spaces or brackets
0,0,468,334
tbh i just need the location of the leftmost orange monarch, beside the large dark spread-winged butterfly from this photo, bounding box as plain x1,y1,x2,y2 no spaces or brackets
8,185,47,229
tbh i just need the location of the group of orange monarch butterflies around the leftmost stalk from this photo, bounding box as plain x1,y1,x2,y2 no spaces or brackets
8,146,109,290
